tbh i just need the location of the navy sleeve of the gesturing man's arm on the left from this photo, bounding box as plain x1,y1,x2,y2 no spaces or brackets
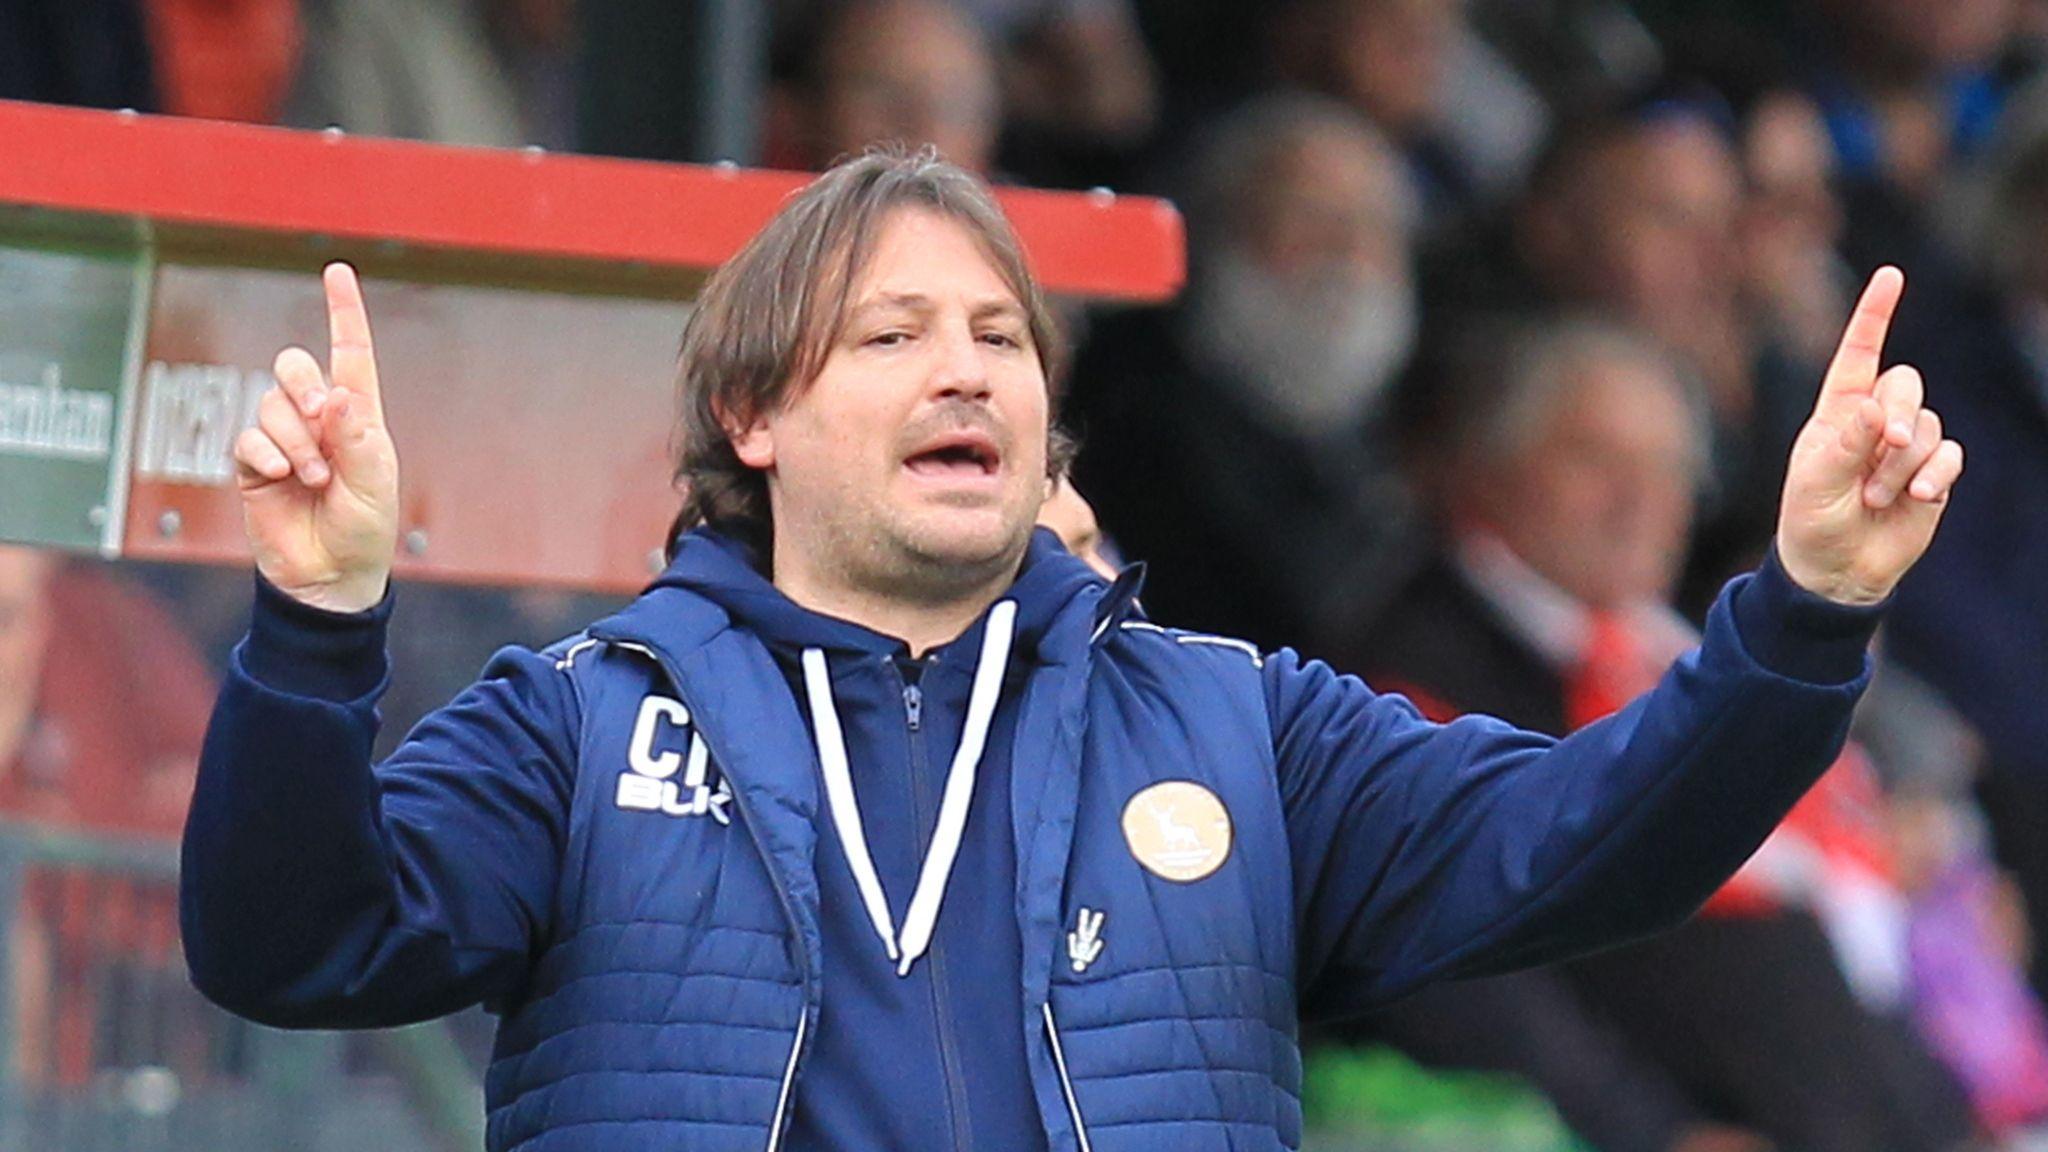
178,586,578,1027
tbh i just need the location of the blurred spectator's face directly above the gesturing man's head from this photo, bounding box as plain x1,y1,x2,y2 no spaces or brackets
813,0,1001,172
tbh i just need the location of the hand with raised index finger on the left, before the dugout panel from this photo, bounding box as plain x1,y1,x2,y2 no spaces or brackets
236,264,397,613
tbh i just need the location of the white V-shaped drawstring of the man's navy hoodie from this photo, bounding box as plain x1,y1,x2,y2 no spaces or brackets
803,601,1018,976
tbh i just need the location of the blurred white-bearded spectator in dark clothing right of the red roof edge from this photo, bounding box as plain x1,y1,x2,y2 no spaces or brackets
1069,96,1415,650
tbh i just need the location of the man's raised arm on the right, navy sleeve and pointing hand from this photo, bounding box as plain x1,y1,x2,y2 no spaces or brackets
1268,269,1962,1013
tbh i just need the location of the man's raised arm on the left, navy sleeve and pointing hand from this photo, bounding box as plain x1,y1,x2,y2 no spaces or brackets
180,264,578,1027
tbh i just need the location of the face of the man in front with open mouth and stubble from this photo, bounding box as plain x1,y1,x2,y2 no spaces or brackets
733,207,1049,596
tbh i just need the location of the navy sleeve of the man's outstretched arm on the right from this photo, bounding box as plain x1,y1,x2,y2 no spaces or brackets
1266,560,1880,1017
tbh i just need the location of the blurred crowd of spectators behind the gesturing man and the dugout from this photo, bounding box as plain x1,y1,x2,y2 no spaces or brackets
0,0,2048,1152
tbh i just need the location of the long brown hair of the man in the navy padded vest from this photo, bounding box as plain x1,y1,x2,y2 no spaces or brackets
668,148,1073,562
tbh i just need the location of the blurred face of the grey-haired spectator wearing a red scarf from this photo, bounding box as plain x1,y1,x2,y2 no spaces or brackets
1483,355,1700,609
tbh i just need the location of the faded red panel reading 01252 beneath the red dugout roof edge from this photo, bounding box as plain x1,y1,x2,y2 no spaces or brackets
125,264,688,590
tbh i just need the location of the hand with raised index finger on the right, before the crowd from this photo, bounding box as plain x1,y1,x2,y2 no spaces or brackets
1778,266,1962,605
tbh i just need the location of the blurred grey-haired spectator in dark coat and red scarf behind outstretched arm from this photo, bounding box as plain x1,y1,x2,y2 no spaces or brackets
1348,322,1972,1152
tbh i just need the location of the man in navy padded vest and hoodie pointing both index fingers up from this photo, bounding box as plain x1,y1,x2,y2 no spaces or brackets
182,154,1960,1152
